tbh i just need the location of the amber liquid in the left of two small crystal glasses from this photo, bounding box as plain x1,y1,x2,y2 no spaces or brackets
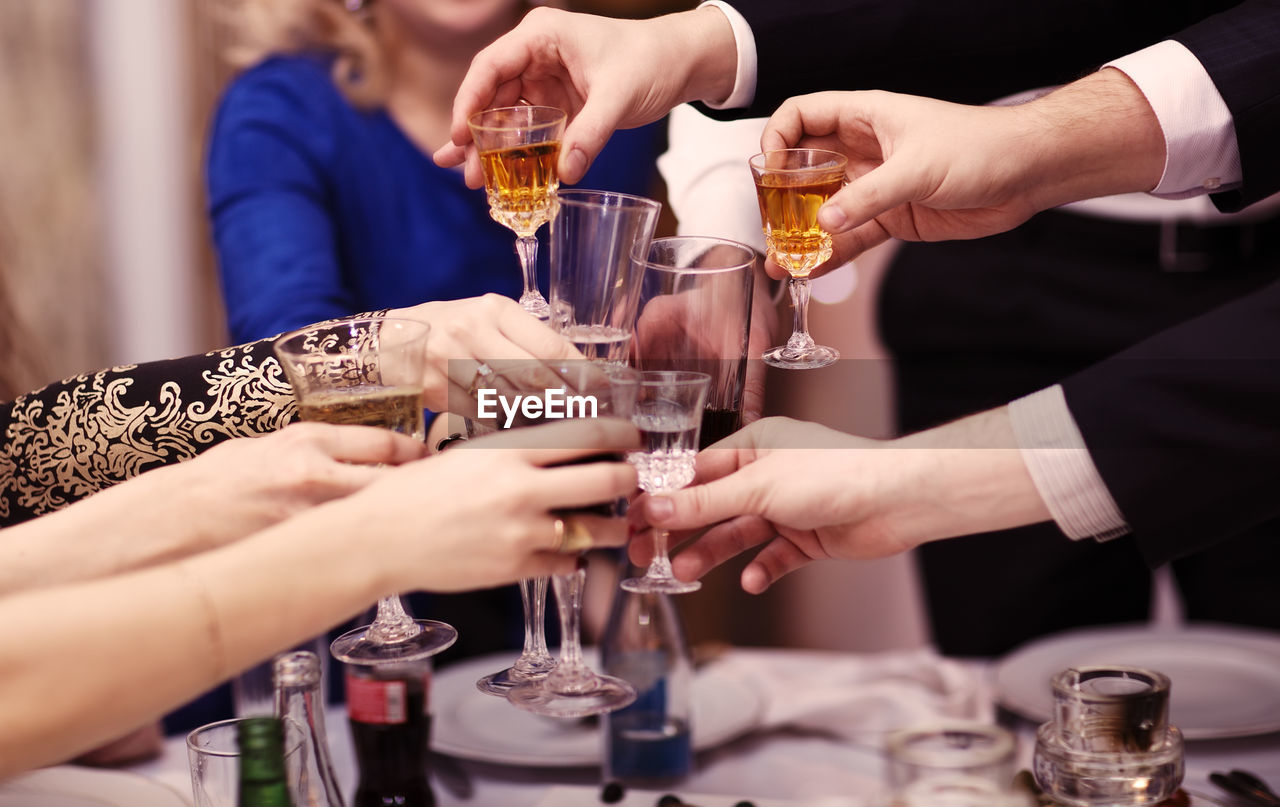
480,141,559,237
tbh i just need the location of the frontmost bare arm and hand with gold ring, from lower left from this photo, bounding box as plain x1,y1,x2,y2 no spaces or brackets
0,421,637,779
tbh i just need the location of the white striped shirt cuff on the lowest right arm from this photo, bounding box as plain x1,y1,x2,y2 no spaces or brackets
1009,384,1129,541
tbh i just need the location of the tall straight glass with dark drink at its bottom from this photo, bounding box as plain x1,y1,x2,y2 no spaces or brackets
634,236,760,448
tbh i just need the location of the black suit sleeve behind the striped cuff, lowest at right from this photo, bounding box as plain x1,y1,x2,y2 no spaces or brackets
1062,283,1280,566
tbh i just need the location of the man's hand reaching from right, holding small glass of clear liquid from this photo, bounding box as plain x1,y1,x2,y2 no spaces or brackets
630,409,1048,593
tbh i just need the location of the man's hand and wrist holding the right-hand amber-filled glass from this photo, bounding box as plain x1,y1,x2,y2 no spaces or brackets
760,69,1165,271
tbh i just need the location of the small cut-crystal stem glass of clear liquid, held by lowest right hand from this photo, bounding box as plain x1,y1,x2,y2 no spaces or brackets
622,370,712,594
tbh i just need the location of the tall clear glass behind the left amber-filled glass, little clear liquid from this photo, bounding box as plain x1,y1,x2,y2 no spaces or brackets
550,188,662,364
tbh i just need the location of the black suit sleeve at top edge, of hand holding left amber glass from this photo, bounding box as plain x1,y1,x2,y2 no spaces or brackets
704,0,1239,118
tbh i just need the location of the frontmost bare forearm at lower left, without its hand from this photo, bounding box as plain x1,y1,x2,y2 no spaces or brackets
0,509,383,779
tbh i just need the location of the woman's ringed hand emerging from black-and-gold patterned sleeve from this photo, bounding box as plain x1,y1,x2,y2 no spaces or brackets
387,295,582,415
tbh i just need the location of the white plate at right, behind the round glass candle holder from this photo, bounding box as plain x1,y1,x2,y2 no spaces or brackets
996,625,1280,739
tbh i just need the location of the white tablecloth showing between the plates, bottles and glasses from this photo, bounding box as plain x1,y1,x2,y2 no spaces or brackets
133,649,1280,807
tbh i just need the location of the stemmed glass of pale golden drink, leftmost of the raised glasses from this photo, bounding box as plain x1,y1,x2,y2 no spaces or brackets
273,316,458,665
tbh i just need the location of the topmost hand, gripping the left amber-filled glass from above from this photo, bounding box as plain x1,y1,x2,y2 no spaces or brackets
435,8,737,187
